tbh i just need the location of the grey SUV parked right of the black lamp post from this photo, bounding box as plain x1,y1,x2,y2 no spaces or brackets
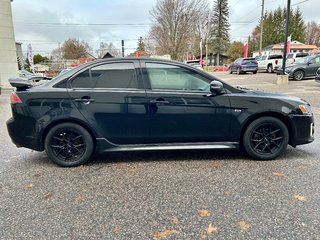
285,55,320,81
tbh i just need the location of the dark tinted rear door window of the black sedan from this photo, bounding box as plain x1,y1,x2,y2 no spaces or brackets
91,63,138,88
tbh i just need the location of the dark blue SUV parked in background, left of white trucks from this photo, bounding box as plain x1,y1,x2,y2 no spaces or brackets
229,58,258,74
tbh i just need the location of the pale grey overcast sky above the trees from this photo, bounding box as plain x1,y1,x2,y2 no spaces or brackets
12,0,320,55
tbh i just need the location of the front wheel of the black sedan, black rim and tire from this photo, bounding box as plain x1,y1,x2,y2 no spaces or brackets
242,117,289,160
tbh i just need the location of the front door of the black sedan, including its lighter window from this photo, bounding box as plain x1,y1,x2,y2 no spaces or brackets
144,62,230,143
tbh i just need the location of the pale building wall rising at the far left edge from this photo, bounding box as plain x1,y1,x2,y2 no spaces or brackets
0,0,18,88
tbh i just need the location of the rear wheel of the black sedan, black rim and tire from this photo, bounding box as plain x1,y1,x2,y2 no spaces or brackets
45,123,94,167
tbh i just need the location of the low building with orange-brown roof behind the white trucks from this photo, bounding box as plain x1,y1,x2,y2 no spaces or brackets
252,41,318,57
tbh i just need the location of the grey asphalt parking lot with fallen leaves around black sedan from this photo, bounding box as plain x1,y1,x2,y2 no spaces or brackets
0,73,320,240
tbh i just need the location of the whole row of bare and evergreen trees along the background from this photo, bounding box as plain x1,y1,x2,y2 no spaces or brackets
33,0,320,62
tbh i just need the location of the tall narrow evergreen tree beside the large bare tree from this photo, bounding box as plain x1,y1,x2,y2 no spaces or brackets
209,0,230,65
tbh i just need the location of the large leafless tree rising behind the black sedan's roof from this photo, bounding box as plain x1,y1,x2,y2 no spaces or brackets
150,0,207,59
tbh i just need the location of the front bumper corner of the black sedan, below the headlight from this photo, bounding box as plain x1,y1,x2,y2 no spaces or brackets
290,115,314,147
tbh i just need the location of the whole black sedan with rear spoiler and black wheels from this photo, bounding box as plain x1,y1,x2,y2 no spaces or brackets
7,59,314,167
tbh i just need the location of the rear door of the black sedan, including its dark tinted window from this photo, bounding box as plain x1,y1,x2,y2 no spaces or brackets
69,61,149,144
